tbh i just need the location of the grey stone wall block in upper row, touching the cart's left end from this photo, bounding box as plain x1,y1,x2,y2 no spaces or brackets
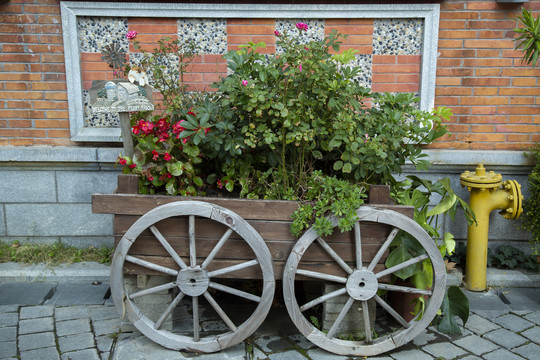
56,171,118,203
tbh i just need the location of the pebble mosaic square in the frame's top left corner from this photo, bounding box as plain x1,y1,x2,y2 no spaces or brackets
77,16,129,53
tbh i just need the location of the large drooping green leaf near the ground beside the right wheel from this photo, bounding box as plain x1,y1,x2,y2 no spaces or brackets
437,286,469,335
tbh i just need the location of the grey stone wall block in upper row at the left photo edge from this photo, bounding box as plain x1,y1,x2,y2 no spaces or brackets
0,170,57,203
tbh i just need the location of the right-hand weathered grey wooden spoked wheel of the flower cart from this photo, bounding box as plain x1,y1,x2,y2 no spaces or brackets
283,206,446,356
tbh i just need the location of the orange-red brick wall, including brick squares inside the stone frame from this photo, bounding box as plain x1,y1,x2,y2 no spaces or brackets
0,0,540,150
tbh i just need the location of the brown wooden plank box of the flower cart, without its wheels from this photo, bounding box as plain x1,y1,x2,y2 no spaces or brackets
92,175,414,279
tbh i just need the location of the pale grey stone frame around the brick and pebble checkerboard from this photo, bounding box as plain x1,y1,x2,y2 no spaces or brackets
60,1,440,142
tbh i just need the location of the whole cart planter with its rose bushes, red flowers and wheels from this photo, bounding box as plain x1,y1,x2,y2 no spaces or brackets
94,23,468,354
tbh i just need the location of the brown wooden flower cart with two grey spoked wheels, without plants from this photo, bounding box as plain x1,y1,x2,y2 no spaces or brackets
92,175,446,356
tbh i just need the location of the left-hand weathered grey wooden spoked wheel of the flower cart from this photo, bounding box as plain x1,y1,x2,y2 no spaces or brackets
111,201,275,352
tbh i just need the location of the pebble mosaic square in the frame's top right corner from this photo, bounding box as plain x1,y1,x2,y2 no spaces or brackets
373,19,424,55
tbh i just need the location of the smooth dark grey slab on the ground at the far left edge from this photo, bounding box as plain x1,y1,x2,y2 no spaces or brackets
0,283,56,305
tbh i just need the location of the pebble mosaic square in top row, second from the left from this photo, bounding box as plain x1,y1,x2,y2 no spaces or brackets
178,19,227,54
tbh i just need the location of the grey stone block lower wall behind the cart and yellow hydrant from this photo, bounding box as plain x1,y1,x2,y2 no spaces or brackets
0,147,532,250
